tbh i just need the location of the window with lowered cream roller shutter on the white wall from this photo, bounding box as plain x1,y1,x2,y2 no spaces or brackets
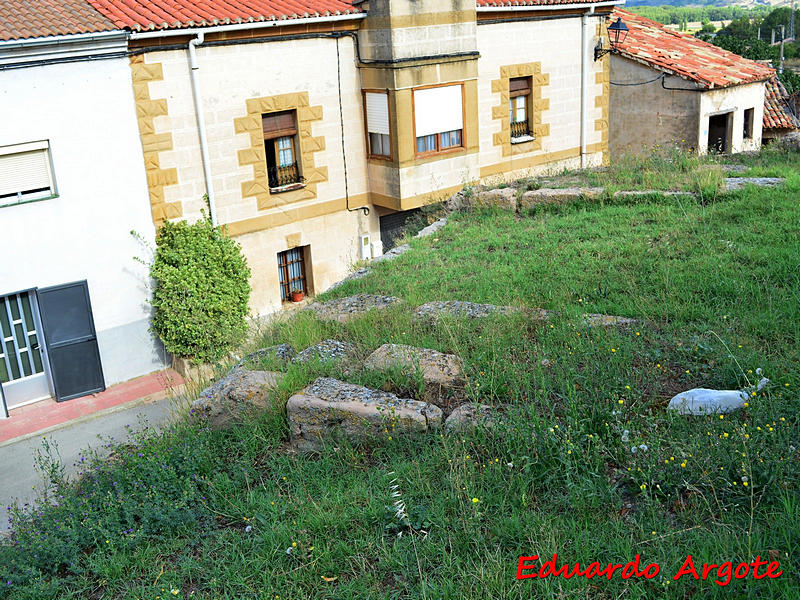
0,140,57,206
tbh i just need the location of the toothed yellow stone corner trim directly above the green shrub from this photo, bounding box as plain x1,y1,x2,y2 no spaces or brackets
130,55,183,227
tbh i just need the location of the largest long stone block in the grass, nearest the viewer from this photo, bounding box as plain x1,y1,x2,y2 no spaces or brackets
286,377,442,452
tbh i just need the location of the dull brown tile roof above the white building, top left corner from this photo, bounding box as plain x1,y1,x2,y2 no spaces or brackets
0,0,115,41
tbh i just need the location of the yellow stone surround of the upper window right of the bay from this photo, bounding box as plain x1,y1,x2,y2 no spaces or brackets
492,62,550,156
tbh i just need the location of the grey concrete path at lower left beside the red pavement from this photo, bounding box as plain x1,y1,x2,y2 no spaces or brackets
0,397,181,516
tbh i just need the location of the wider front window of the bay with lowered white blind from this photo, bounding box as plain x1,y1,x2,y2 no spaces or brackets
414,83,464,155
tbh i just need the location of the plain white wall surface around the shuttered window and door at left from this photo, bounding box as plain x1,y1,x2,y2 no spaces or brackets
0,59,163,384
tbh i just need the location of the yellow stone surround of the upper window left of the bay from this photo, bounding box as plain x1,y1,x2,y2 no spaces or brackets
231,92,328,210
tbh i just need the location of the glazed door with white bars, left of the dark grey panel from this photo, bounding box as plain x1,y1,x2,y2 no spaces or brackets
0,291,52,408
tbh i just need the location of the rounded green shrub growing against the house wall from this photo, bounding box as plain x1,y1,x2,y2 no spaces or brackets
150,219,250,362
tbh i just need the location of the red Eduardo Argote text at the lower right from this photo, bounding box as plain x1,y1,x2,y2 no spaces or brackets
517,554,783,586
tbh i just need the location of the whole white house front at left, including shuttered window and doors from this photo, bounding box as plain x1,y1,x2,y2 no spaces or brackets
0,2,167,417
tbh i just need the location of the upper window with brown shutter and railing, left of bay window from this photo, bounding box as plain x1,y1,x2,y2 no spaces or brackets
261,110,303,192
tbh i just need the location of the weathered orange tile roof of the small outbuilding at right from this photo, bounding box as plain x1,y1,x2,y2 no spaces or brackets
612,8,775,89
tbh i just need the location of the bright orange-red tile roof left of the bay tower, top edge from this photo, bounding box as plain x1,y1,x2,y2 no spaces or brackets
87,0,362,31
